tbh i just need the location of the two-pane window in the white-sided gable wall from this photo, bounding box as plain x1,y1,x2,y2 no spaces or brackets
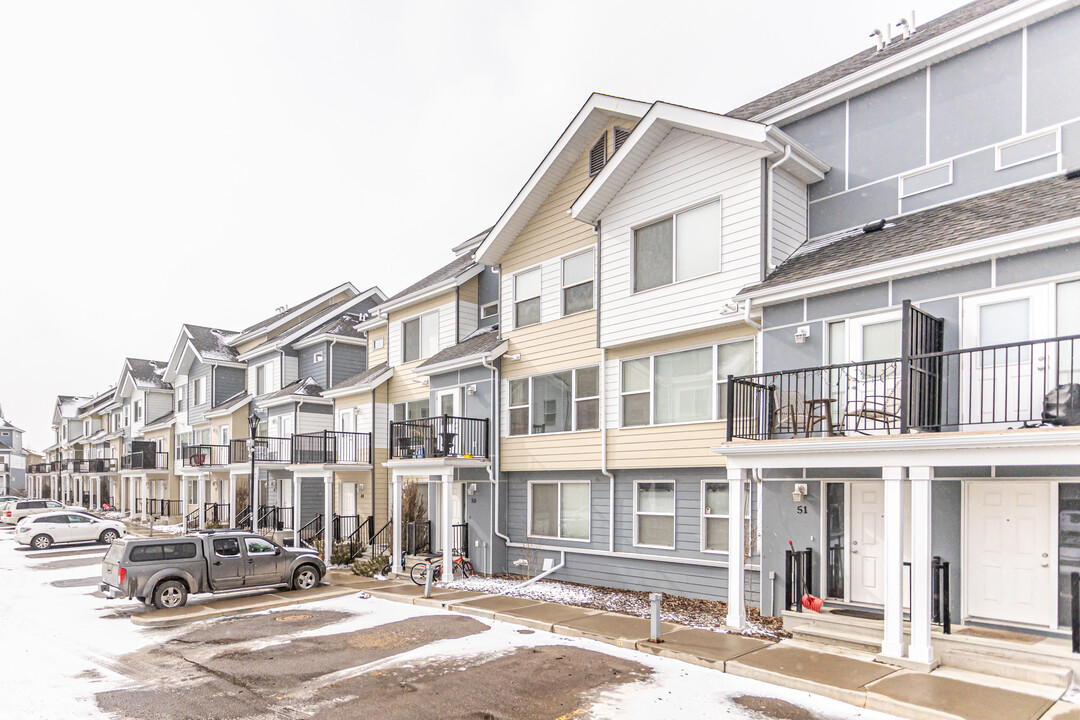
634,201,721,293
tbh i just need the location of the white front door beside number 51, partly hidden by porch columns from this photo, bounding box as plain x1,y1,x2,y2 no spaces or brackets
849,480,912,607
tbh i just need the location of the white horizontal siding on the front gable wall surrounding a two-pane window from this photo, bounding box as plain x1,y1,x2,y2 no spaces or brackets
599,130,765,347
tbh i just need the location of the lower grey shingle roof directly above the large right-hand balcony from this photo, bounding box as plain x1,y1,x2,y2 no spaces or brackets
742,175,1080,295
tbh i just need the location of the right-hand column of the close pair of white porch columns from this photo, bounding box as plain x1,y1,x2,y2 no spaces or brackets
907,465,934,665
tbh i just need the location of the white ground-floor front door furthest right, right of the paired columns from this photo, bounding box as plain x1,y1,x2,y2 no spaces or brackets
964,480,1056,625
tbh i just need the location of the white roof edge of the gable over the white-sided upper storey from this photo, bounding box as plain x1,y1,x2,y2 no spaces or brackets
570,103,829,225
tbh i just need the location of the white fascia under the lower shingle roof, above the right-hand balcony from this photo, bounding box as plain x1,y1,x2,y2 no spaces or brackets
734,216,1080,304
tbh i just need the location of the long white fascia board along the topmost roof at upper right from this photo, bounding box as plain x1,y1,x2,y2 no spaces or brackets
751,0,1080,124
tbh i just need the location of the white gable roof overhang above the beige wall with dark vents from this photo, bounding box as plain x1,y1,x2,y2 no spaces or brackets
474,93,649,266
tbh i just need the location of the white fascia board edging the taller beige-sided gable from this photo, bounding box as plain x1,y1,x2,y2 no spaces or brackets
474,93,650,266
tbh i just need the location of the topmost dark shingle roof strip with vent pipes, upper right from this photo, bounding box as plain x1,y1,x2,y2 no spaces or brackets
727,0,1016,120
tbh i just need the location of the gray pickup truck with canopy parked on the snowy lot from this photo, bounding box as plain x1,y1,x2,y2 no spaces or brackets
99,530,326,609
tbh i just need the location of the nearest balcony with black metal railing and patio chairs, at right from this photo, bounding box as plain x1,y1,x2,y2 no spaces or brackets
727,335,1080,441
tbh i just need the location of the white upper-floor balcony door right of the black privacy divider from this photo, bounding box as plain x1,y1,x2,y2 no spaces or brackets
960,285,1054,424
